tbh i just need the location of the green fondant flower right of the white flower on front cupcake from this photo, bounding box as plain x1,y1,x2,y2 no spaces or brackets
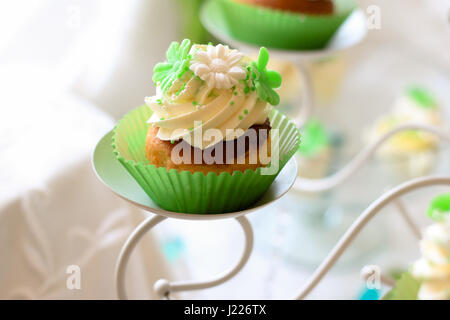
251,47,281,106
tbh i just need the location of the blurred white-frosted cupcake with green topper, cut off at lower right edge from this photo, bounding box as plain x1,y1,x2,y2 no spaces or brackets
383,193,450,300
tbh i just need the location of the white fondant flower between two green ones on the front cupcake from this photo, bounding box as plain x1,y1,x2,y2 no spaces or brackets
190,44,247,89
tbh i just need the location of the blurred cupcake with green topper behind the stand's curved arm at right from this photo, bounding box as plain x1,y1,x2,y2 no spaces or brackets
369,86,442,178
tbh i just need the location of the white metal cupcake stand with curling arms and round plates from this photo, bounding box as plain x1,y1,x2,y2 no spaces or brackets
106,10,450,299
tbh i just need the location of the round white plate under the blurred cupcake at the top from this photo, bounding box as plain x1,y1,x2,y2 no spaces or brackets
200,5,367,61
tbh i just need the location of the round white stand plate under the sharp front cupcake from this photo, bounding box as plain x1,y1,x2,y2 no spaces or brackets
92,131,297,220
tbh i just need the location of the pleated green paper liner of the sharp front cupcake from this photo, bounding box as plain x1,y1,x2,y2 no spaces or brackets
112,105,300,214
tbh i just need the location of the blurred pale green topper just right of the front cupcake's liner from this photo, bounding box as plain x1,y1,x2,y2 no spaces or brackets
298,119,330,157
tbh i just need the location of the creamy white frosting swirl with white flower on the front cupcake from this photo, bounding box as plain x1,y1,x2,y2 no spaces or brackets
145,45,269,149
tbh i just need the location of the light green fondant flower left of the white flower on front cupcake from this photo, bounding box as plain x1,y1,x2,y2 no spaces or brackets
153,39,191,92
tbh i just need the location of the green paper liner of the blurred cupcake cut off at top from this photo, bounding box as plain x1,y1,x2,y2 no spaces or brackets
201,0,356,50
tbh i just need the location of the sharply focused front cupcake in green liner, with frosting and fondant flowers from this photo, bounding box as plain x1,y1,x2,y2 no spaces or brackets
113,39,299,213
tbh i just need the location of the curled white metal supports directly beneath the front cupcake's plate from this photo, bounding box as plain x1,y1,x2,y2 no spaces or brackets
116,215,254,299
